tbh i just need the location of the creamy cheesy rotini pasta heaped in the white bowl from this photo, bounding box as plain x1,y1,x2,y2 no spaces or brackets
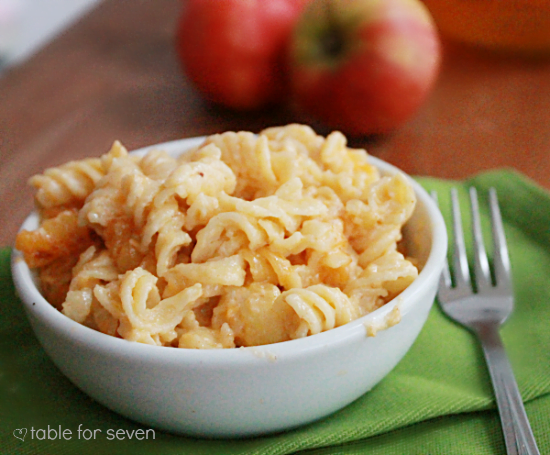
16,124,418,349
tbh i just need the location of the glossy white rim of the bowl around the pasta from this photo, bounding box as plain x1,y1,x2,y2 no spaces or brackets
11,136,447,366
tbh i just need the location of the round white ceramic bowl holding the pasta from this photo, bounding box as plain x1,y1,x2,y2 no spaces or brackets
12,138,447,437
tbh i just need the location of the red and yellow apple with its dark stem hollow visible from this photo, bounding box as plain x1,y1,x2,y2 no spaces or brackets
289,0,441,135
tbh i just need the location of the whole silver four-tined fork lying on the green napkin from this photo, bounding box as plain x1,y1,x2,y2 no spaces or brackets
432,188,539,455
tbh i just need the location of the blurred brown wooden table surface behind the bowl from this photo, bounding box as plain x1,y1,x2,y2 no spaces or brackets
0,0,550,245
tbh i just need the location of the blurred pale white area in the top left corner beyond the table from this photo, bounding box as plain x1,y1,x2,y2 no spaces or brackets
0,0,102,74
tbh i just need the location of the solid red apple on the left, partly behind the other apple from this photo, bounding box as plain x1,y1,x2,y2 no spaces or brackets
176,0,309,109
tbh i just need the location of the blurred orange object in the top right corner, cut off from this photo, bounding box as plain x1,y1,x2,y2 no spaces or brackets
423,0,550,53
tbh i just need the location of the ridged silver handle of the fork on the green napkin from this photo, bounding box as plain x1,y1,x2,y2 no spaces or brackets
474,323,540,455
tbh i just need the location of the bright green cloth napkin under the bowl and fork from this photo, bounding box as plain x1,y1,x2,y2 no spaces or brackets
0,170,550,455
